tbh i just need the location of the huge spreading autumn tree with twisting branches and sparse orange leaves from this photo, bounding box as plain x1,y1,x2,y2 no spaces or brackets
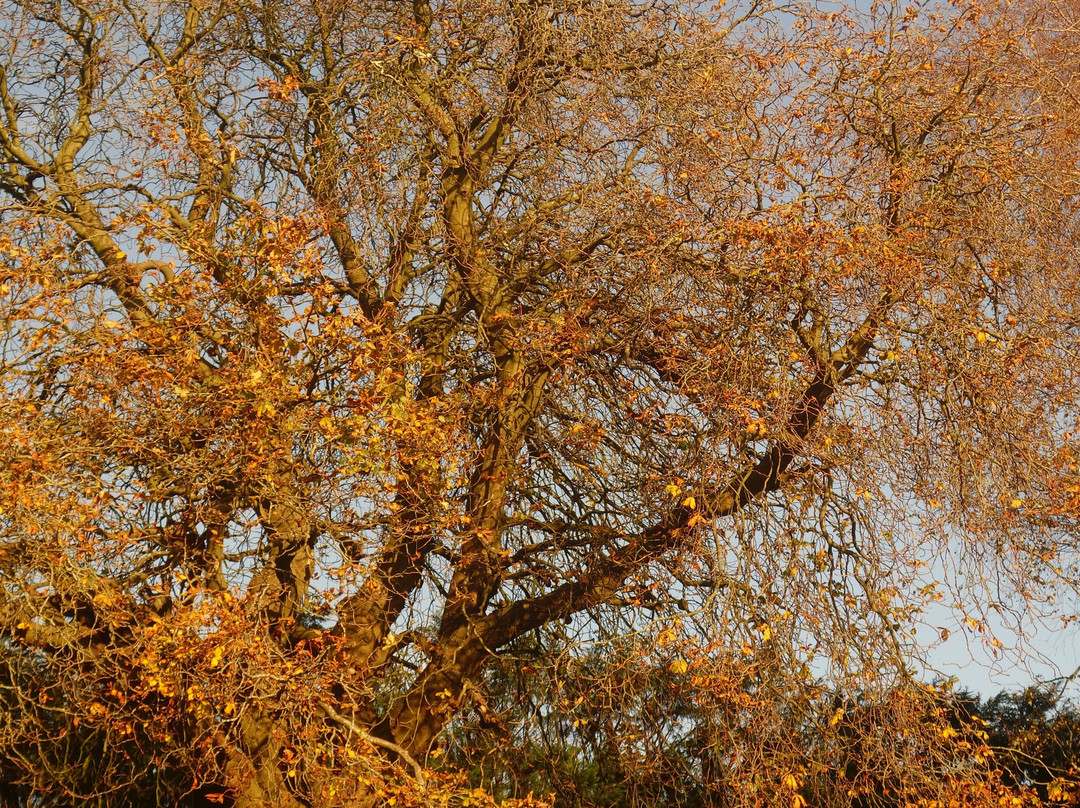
0,0,1080,806
